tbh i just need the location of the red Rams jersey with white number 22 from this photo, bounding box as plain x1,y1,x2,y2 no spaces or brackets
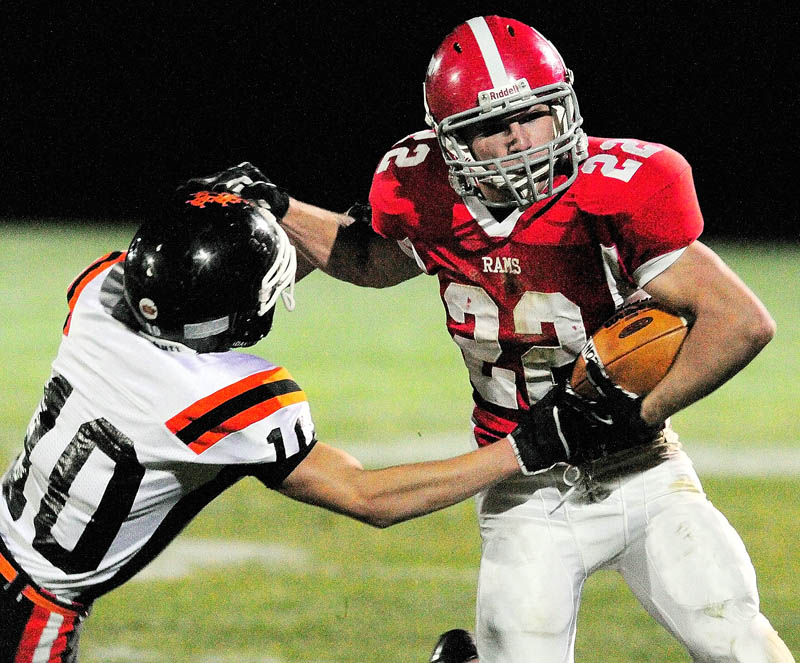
370,131,703,444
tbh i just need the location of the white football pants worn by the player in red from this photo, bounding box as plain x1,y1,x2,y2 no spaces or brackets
476,451,793,663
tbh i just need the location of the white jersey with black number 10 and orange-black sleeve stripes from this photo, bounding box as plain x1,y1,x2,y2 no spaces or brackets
0,253,315,603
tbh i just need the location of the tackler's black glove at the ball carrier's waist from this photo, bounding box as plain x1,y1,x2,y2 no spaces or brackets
509,384,599,474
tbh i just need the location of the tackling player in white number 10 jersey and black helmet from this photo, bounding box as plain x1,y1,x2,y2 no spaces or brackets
0,190,628,663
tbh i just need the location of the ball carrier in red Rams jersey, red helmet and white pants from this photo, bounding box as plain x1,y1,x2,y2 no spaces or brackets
189,16,793,663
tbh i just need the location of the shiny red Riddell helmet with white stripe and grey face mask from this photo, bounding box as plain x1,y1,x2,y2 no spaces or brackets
424,16,586,207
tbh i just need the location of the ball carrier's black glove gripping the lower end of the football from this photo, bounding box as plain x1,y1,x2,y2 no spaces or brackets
584,357,664,460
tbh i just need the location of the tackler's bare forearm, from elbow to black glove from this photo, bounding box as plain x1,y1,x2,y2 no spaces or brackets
349,439,519,527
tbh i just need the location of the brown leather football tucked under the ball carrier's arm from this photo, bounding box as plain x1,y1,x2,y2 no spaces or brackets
570,300,689,398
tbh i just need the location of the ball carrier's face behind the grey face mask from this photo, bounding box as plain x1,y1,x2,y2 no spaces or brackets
466,104,555,202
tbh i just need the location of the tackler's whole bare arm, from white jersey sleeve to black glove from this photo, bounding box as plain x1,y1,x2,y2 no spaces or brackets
279,438,520,527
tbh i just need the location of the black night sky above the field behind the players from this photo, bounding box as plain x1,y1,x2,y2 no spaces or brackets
0,1,800,241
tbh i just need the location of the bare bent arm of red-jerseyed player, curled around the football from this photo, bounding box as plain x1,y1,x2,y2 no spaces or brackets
641,242,775,423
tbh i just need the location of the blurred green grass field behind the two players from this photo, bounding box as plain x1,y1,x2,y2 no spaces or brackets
0,224,800,663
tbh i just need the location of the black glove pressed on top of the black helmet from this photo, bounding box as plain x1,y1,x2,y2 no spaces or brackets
178,161,289,221
